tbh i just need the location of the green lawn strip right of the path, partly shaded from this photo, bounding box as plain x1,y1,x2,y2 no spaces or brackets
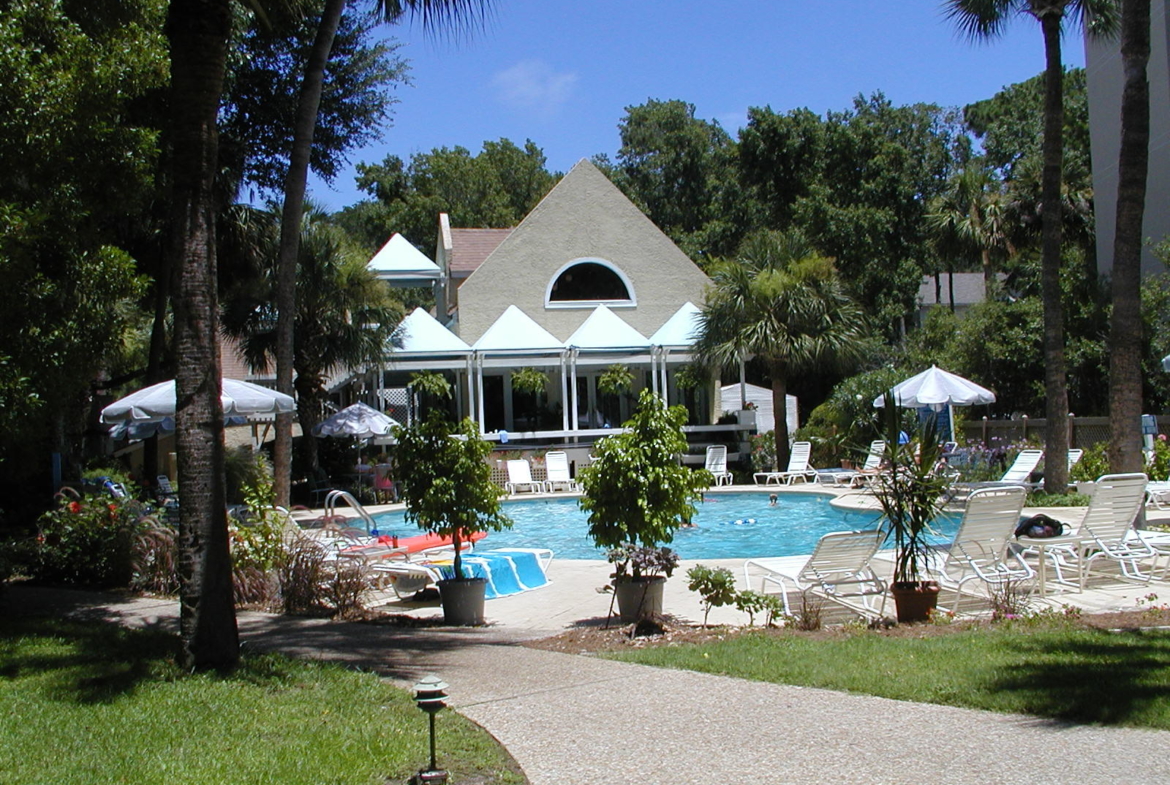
606,620,1170,730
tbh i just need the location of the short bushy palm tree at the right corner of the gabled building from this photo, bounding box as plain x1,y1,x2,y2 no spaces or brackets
695,232,867,466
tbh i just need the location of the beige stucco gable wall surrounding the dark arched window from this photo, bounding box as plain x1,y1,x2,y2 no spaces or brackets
459,159,709,344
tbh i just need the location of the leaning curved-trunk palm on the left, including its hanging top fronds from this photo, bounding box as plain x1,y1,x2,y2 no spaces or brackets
273,0,490,504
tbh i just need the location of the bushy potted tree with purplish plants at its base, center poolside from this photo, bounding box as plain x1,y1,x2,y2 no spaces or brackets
578,390,711,622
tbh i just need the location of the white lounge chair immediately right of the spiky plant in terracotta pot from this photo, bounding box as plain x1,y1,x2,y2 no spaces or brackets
931,486,1035,612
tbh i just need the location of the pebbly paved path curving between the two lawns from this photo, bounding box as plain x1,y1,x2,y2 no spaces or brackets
4,587,1170,785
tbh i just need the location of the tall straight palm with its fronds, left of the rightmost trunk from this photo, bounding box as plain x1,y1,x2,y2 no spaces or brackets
943,0,1117,494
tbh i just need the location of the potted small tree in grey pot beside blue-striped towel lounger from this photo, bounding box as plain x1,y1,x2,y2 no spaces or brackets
394,412,511,626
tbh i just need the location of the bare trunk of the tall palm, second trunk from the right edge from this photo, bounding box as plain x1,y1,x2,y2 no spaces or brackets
1040,11,1068,494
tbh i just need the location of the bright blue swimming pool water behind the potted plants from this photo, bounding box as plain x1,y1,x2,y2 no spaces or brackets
376,493,956,560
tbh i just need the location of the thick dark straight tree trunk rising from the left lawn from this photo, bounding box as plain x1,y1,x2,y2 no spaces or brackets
166,0,240,669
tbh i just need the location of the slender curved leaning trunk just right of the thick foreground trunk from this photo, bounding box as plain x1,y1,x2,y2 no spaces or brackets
273,0,345,507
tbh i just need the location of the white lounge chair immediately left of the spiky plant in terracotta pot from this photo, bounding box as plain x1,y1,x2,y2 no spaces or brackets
743,529,886,618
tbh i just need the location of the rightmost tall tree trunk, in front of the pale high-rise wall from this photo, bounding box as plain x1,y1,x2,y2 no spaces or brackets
1109,0,1150,471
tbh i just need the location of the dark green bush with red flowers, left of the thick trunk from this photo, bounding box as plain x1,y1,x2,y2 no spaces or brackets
27,495,142,587
